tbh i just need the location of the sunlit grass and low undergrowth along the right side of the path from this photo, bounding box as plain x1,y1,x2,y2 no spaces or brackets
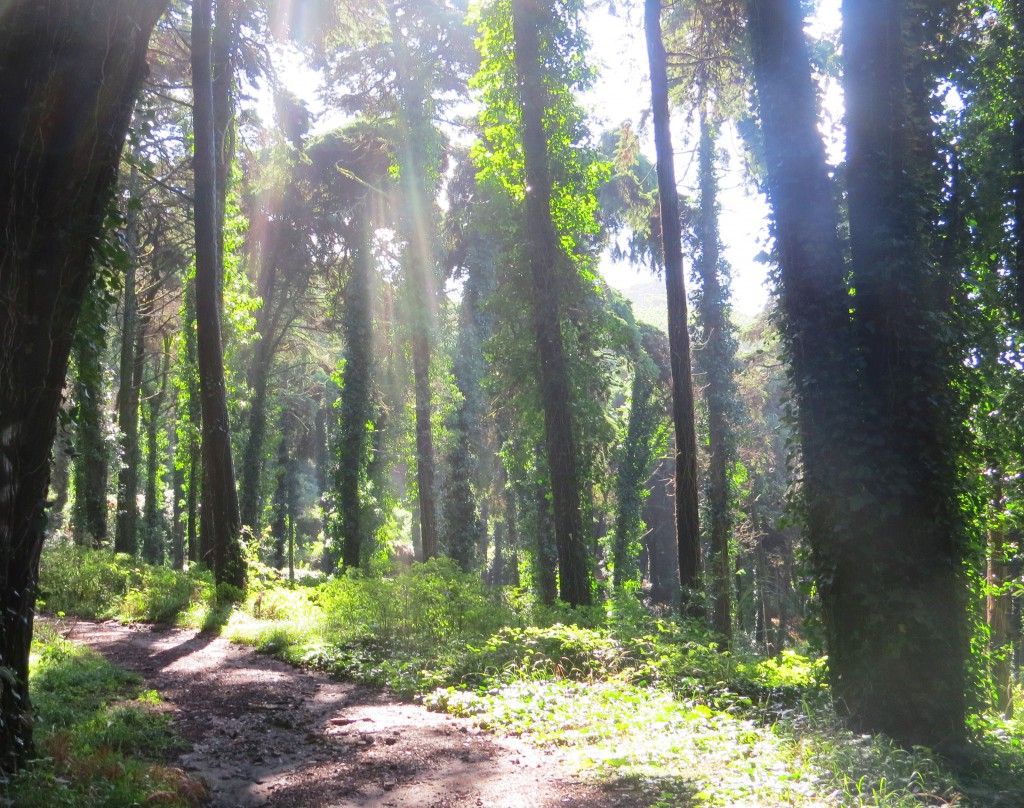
34,540,1024,808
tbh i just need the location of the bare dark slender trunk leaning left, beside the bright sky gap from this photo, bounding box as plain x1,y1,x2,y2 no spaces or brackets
644,0,703,618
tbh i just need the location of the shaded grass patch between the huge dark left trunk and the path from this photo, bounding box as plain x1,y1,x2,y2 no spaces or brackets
0,626,206,808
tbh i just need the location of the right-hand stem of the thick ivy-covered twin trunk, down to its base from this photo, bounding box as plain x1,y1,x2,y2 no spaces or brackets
829,0,968,746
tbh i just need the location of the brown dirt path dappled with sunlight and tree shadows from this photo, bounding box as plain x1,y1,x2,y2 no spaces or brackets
70,622,640,808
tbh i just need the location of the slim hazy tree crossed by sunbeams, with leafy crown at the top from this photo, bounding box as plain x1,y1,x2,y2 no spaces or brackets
311,0,472,559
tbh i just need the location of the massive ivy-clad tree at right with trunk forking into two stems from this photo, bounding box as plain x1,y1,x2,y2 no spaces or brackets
748,0,966,748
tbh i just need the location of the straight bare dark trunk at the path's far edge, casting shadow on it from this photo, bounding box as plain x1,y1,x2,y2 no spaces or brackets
191,0,246,588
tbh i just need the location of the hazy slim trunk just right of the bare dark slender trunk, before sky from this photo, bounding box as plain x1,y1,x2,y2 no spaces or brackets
694,110,738,647
